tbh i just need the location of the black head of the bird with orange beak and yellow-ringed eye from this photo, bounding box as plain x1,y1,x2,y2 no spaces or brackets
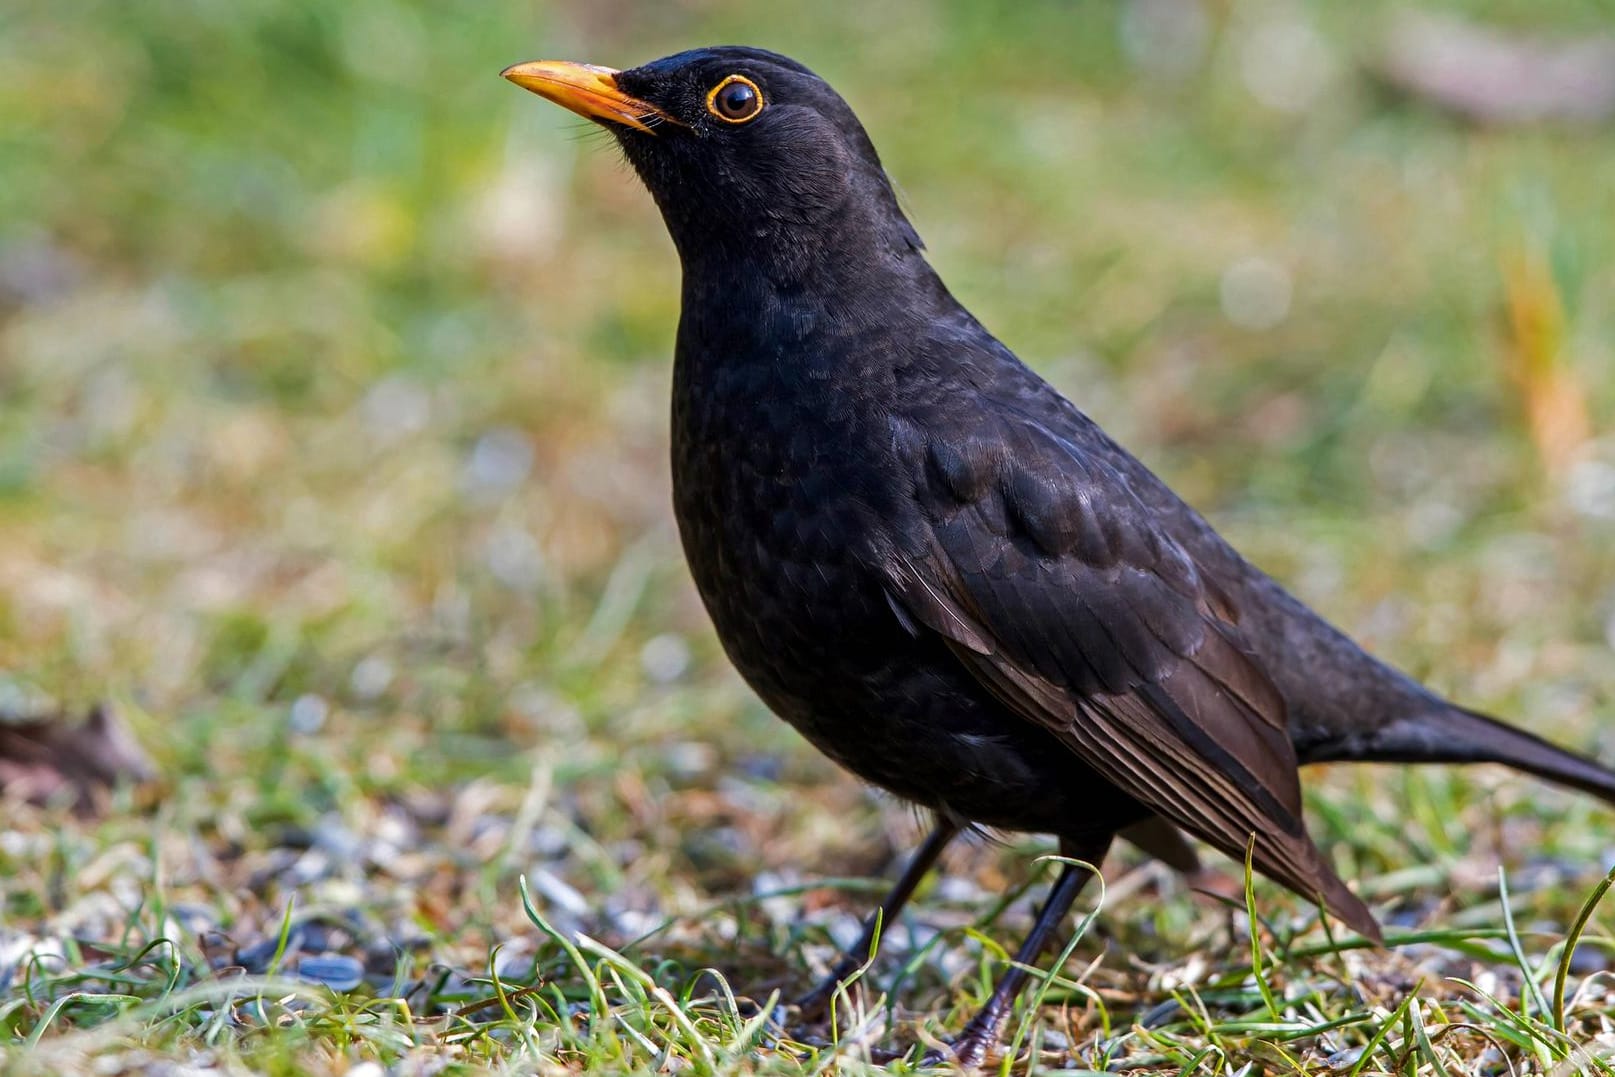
502,47,921,277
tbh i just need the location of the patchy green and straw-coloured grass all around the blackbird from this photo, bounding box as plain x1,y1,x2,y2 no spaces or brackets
0,0,1615,1075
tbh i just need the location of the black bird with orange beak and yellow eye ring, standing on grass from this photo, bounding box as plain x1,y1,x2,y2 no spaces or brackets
504,47,1615,1066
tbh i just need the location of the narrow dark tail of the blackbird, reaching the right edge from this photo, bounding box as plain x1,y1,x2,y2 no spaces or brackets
1305,707,1615,804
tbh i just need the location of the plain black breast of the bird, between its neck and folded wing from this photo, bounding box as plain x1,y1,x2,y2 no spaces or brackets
672,340,901,717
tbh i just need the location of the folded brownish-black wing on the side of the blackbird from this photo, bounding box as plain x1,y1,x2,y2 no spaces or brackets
885,413,1379,938
